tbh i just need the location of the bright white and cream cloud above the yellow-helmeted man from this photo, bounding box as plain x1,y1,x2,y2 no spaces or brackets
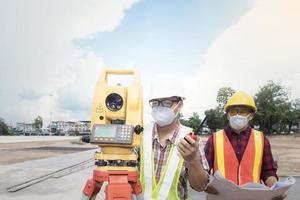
180,0,300,117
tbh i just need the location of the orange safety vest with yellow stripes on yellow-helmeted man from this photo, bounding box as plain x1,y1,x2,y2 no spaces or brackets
213,129,264,185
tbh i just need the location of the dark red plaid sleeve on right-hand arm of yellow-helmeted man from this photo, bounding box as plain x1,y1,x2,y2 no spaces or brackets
260,137,278,182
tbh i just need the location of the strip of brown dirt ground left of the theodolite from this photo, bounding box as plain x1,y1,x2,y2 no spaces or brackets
0,140,97,165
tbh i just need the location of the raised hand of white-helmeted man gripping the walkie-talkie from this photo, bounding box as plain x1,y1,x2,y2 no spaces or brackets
177,135,201,163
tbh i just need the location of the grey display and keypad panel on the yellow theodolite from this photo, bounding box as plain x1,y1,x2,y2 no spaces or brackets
91,124,134,144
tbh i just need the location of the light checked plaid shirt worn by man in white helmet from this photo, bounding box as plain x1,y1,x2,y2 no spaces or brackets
153,124,208,199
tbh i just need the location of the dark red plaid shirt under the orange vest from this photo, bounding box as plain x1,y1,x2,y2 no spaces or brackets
204,126,278,182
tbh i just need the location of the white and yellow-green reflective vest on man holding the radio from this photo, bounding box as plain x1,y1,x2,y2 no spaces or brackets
140,124,191,200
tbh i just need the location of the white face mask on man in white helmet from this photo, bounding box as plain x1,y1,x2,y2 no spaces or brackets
151,106,178,127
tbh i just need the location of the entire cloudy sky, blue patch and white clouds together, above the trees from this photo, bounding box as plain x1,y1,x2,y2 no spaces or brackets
0,0,300,124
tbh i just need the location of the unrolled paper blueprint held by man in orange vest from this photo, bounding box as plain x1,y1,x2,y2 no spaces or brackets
207,171,296,200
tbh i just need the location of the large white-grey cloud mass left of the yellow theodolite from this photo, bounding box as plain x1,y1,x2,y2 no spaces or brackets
0,0,136,125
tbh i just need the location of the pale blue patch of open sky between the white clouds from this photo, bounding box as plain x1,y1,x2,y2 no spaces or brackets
75,0,251,74
